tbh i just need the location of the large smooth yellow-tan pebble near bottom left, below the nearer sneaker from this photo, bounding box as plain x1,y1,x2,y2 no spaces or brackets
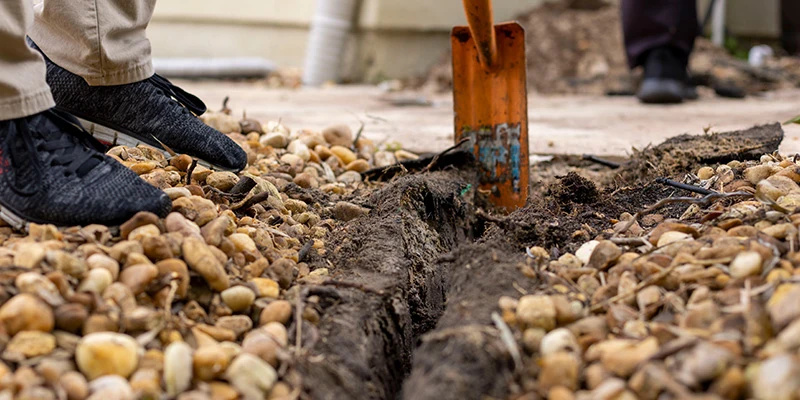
75,332,143,380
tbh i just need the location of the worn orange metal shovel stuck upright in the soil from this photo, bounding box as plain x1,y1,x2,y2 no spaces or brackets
451,0,529,212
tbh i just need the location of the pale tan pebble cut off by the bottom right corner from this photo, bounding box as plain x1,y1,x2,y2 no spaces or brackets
746,354,800,400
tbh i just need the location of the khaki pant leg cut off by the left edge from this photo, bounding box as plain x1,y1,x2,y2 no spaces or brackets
0,0,55,120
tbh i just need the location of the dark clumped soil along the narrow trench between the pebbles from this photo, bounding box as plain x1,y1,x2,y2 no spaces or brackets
289,125,783,400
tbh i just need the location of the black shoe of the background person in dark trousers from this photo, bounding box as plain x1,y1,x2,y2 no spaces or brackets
636,47,697,104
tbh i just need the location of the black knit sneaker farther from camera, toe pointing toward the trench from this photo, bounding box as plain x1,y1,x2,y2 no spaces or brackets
31,44,247,171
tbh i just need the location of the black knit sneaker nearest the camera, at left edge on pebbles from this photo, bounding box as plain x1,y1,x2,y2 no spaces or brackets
0,110,172,229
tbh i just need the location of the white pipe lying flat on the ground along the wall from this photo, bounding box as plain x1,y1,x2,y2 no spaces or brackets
153,57,275,78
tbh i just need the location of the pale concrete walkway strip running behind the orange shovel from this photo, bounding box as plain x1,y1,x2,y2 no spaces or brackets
179,81,800,155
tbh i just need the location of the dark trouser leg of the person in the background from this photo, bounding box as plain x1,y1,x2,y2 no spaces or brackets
622,0,699,68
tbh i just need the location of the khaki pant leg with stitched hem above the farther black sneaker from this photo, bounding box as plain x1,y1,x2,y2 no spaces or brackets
28,0,155,86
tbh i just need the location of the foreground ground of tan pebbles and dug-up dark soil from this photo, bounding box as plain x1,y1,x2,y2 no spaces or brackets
0,97,800,400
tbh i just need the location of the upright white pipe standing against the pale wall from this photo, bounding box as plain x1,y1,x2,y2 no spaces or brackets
303,0,358,86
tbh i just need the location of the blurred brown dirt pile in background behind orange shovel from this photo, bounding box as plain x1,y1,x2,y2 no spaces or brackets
424,0,800,97
